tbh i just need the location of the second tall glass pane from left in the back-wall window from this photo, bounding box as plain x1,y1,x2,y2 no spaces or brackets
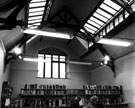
45,55,51,78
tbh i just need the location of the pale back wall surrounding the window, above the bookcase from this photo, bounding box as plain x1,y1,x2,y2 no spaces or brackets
10,38,89,98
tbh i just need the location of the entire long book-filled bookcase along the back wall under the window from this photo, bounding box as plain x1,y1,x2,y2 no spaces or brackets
19,84,127,108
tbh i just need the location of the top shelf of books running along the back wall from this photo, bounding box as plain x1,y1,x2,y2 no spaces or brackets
20,84,122,95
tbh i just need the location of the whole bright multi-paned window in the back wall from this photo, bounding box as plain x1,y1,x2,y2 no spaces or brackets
37,54,66,78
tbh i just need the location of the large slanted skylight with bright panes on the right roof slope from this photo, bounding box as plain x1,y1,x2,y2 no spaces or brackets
84,0,122,34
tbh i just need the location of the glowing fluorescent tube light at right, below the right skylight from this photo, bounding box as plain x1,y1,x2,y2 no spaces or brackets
97,38,133,47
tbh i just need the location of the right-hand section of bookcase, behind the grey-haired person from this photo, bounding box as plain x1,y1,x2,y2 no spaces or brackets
83,85,128,108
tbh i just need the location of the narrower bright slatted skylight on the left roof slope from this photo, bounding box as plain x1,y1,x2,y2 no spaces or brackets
27,0,52,28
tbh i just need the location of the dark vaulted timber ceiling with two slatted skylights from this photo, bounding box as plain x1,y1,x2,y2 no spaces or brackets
0,0,135,72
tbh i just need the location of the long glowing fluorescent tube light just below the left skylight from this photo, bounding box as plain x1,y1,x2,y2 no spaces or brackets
23,29,73,39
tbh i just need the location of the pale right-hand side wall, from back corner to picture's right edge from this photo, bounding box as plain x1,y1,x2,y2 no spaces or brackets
90,52,135,108
